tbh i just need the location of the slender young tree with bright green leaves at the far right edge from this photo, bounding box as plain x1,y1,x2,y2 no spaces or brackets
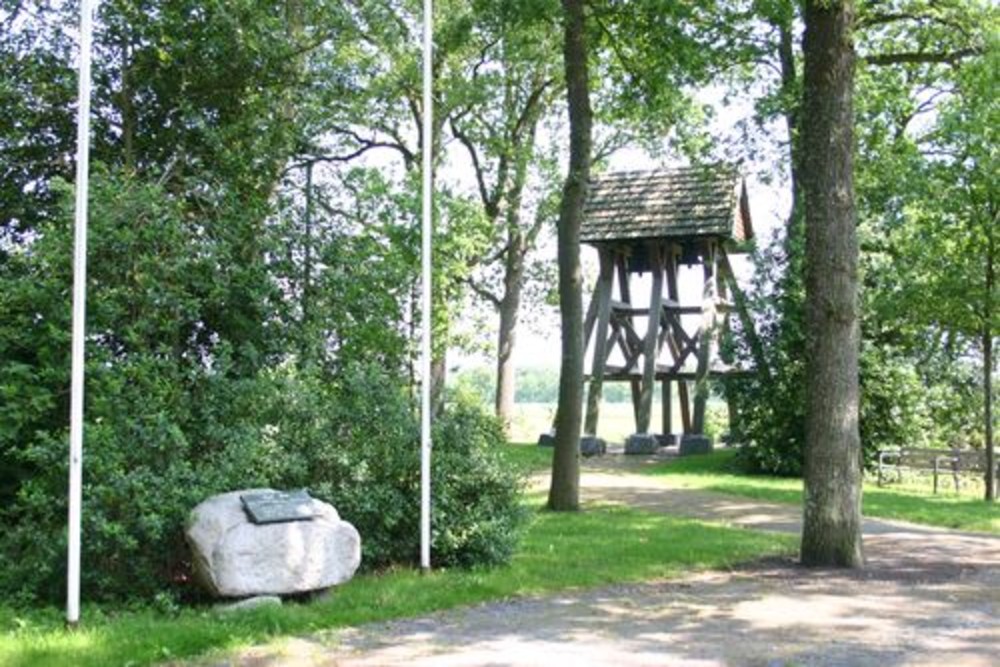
891,44,1000,501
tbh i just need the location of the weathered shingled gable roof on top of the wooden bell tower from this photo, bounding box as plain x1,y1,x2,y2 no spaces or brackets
580,165,753,243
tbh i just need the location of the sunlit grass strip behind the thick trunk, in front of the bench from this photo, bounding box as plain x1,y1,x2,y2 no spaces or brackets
642,451,1000,533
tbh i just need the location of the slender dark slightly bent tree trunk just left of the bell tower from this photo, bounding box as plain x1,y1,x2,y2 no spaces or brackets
548,0,591,511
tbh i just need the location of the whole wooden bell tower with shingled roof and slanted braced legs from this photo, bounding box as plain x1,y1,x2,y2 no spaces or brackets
581,166,759,454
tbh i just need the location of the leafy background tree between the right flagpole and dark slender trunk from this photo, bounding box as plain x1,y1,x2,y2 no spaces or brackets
450,6,559,425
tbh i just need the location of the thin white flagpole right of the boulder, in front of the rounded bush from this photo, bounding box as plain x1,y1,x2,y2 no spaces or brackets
420,0,434,571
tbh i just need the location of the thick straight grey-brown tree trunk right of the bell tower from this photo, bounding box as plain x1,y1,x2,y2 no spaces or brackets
801,0,864,567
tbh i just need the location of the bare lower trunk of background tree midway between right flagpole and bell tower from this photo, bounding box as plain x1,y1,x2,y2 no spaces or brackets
496,228,525,430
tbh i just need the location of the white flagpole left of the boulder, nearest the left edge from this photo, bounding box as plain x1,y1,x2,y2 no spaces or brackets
66,0,94,626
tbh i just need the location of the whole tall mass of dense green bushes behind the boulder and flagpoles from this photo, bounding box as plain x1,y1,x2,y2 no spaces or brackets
0,170,522,603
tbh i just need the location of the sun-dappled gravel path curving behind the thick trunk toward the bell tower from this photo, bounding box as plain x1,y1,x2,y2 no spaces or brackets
205,457,1000,667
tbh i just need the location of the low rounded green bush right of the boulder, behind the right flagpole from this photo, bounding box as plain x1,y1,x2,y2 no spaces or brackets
279,366,525,569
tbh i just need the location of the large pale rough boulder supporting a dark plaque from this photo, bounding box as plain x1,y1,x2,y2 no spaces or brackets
186,489,361,598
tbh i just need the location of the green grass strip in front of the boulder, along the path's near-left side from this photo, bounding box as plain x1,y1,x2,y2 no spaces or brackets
0,504,795,667
